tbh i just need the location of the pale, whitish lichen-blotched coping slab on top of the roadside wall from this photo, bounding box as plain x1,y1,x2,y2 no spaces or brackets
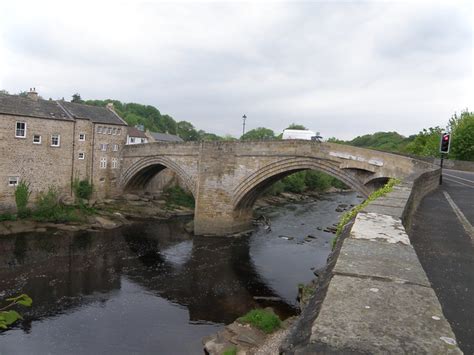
350,212,410,245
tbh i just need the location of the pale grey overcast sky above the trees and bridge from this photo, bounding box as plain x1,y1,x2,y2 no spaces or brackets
0,0,474,139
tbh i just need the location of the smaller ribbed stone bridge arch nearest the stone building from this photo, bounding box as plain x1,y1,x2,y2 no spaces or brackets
121,156,196,198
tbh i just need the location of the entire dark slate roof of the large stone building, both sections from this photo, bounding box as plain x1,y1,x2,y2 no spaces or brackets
0,94,127,126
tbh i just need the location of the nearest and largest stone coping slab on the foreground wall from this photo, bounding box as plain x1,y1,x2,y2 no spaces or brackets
306,275,462,354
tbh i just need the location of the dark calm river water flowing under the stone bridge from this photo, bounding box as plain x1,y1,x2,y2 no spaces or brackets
0,192,360,355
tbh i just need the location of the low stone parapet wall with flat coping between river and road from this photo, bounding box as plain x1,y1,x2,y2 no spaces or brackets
280,167,462,354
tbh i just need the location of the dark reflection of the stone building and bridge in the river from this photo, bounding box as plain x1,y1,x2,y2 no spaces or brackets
0,223,296,327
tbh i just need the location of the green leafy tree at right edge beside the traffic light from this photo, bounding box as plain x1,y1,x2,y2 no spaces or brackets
449,109,474,161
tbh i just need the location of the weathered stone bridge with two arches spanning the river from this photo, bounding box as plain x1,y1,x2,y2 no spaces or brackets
120,140,431,235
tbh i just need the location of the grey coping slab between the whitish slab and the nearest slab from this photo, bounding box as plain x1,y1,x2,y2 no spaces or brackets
333,239,431,287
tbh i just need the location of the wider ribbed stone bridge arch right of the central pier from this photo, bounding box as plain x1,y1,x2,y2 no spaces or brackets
233,157,370,212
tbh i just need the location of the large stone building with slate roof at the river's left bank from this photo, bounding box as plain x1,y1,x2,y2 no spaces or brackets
0,90,128,209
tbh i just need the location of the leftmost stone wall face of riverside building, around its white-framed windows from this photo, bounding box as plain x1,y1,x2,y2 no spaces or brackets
0,115,74,209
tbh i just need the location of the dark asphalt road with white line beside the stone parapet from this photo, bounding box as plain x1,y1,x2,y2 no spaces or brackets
411,169,474,355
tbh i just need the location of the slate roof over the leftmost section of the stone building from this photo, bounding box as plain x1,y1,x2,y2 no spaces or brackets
0,94,73,121
